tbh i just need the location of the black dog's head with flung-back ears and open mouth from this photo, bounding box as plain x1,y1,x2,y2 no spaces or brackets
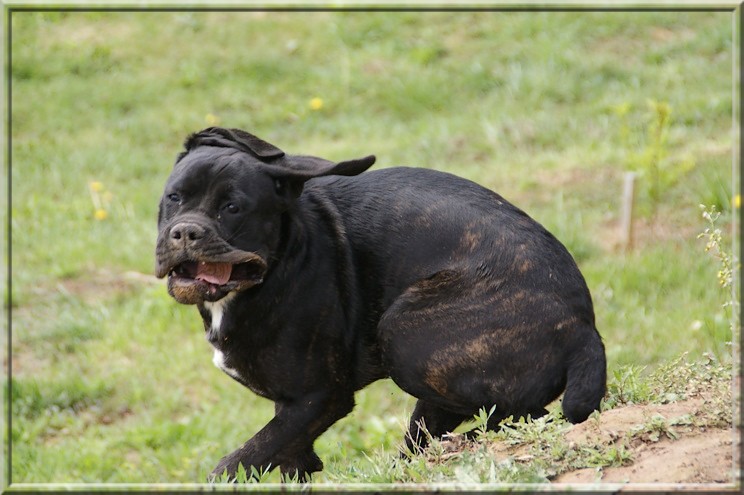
155,127,375,304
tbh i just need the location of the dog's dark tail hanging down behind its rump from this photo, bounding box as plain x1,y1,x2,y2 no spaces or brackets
563,328,607,423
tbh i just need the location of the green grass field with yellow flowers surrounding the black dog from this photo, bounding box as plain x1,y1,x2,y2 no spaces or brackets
6,12,739,483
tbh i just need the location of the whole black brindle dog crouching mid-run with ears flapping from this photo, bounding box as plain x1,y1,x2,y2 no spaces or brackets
157,128,606,479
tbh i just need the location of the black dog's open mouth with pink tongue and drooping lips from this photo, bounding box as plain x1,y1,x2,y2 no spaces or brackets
168,257,266,304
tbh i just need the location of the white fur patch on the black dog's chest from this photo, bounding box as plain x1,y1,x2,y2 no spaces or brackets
204,294,268,396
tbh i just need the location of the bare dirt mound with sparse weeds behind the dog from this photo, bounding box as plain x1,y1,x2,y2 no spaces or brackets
439,392,741,491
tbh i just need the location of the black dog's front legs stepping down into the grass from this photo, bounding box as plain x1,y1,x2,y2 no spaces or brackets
211,392,354,481
